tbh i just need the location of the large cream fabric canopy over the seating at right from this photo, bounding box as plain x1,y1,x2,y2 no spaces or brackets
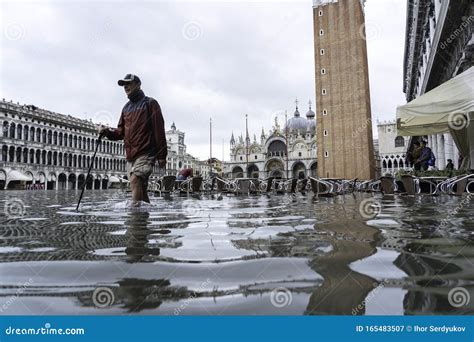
397,67,474,136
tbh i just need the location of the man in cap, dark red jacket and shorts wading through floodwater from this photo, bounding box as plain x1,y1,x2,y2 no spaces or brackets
98,74,168,205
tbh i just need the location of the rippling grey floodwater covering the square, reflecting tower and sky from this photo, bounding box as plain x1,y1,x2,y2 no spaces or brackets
0,190,474,315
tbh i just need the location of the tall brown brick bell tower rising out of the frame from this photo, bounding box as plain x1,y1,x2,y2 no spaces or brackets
313,0,375,179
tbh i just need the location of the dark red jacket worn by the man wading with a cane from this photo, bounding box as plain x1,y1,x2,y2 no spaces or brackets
104,90,168,161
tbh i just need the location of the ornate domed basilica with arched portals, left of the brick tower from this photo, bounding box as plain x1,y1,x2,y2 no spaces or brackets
224,102,317,178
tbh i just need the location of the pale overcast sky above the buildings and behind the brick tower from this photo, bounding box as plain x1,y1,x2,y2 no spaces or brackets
0,0,406,160
